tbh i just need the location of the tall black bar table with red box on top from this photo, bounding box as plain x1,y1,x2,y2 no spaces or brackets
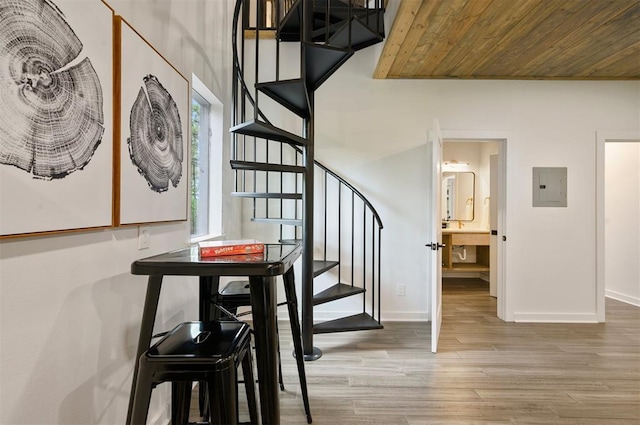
127,244,303,425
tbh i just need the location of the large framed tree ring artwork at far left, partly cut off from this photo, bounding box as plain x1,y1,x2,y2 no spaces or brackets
0,0,114,238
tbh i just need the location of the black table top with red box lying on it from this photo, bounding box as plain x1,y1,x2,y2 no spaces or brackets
131,244,302,276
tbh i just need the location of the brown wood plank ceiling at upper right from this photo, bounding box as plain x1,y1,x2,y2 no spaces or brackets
374,0,640,80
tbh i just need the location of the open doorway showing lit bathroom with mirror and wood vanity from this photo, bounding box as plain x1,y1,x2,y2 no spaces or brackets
442,131,509,320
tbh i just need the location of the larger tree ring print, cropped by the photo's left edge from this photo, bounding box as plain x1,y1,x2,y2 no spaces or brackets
0,0,104,180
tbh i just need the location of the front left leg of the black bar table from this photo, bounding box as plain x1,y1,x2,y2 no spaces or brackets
126,275,162,425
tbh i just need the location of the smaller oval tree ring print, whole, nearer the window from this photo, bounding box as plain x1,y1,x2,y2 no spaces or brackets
127,75,183,192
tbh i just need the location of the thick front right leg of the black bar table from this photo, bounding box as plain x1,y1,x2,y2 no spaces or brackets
249,276,280,425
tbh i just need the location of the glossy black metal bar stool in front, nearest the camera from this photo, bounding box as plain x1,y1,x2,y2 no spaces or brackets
131,320,258,425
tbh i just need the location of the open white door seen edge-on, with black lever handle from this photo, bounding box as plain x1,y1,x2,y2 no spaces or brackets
427,120,442,353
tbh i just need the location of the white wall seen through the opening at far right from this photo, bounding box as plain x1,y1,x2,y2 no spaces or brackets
605,142,640,306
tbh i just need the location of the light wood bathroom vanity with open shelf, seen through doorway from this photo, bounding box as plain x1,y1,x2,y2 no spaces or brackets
442,228,489,272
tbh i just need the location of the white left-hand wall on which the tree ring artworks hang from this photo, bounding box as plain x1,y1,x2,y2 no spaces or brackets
0,0,240,425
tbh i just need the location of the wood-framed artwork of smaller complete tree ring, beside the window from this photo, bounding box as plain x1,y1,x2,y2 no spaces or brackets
115,16,190,224
